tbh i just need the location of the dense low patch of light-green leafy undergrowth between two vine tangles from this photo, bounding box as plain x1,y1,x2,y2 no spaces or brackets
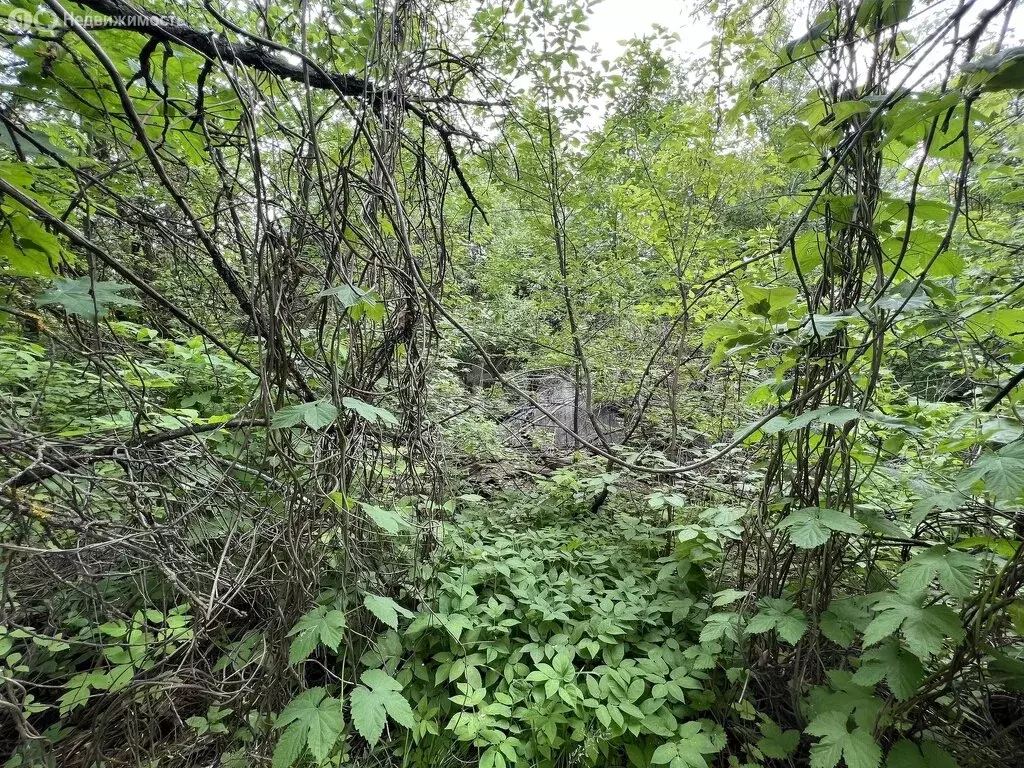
380,505,741,768
